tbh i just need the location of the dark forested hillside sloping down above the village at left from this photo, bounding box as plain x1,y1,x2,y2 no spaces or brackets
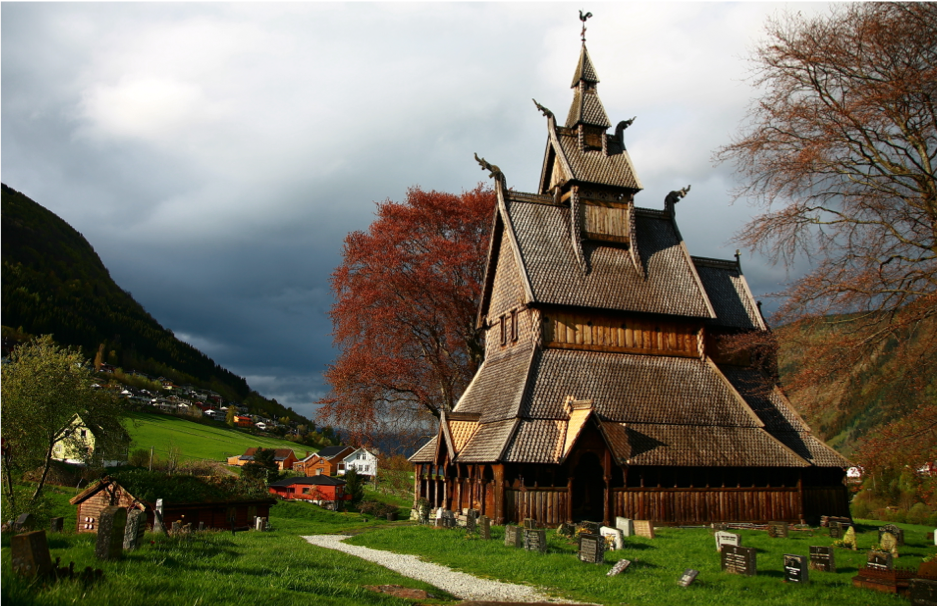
0,183,308,426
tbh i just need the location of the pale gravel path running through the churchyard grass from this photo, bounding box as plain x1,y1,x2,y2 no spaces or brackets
303,534,588,604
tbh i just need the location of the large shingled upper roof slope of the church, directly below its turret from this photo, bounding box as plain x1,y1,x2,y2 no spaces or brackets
505,195,714,318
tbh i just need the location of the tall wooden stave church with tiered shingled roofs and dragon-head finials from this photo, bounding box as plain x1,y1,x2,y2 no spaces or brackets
411,43,849,524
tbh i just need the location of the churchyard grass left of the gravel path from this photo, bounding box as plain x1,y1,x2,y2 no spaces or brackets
0,495,452,606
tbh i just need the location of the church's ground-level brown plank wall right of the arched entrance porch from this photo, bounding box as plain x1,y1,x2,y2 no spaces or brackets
612,488,800,524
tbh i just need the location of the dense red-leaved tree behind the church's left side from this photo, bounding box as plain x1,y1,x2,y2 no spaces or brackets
319,185,495,441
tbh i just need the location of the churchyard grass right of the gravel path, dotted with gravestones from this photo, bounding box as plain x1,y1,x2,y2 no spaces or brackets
349,521,935,606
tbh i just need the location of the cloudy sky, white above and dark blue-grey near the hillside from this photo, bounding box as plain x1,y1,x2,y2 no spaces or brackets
0,2,826,416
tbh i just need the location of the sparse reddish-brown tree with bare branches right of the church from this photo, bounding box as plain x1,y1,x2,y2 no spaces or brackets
718,2,937,504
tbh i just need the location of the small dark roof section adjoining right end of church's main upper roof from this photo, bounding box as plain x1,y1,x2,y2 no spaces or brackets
692,257,768,330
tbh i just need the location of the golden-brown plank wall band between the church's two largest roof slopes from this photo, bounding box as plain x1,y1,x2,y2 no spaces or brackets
543,311,700,358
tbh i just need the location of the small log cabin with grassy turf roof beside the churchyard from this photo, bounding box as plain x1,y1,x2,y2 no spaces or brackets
69,471,276,532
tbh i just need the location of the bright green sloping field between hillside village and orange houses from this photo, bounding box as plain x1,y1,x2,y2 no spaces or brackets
125,412,316,461
